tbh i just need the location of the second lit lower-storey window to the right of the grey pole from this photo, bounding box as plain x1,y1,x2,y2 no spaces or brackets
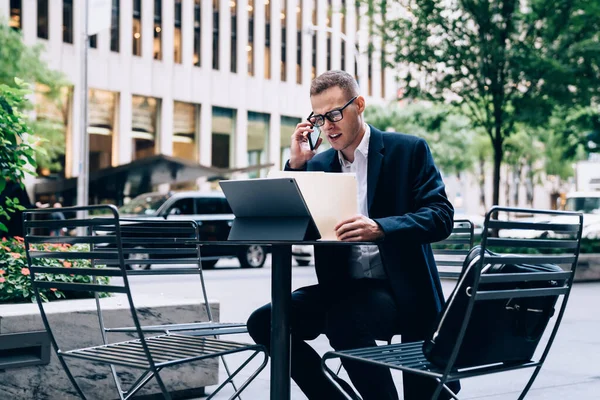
131,96,159,160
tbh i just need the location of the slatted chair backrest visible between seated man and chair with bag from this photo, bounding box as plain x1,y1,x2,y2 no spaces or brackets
431,219,474,278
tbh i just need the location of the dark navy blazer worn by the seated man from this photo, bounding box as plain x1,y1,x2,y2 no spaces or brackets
286,127,454,340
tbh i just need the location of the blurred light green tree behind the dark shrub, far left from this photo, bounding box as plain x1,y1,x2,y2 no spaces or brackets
0,21,68,170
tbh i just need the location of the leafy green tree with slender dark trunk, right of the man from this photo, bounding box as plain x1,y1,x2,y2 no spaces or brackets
385,0,600,204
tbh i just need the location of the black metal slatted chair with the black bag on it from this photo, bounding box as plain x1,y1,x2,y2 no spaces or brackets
321,206,583,400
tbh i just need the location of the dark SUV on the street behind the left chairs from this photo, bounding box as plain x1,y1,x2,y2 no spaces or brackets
119,191,268,269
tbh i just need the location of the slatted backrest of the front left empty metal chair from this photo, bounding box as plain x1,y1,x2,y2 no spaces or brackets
23,205,152,351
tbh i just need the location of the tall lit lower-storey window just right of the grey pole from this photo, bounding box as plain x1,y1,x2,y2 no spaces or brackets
87,89,116,172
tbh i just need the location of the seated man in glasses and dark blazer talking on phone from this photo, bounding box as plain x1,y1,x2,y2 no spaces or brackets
248,71,454,400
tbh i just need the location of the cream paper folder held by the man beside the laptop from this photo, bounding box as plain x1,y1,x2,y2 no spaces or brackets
269,171,359,240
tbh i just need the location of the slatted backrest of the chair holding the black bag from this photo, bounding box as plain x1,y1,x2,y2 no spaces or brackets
434,207,583,373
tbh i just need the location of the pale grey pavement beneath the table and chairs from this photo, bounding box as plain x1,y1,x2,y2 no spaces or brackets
127,261,600,400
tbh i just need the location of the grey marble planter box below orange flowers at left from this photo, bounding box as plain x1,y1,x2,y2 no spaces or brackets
0,296,219,400
